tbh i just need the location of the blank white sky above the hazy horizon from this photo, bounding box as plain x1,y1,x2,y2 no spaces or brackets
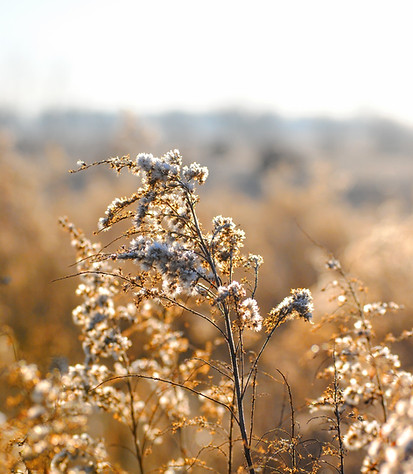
0,0,413,124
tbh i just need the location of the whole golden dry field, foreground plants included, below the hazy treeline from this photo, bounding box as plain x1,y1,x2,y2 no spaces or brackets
0,116,413,474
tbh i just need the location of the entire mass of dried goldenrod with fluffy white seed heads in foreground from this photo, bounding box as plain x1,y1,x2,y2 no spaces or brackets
0,150,413,474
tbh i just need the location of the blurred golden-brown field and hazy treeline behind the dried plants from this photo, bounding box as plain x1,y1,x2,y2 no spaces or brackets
0,107,413,386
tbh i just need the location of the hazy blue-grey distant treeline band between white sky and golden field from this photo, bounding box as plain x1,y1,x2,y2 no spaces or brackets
0,110,413,204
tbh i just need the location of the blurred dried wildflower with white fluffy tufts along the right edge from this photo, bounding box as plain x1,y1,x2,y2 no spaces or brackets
313,260,413,474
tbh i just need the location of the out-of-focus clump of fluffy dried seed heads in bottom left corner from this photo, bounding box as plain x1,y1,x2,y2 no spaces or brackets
0,361,110,473
